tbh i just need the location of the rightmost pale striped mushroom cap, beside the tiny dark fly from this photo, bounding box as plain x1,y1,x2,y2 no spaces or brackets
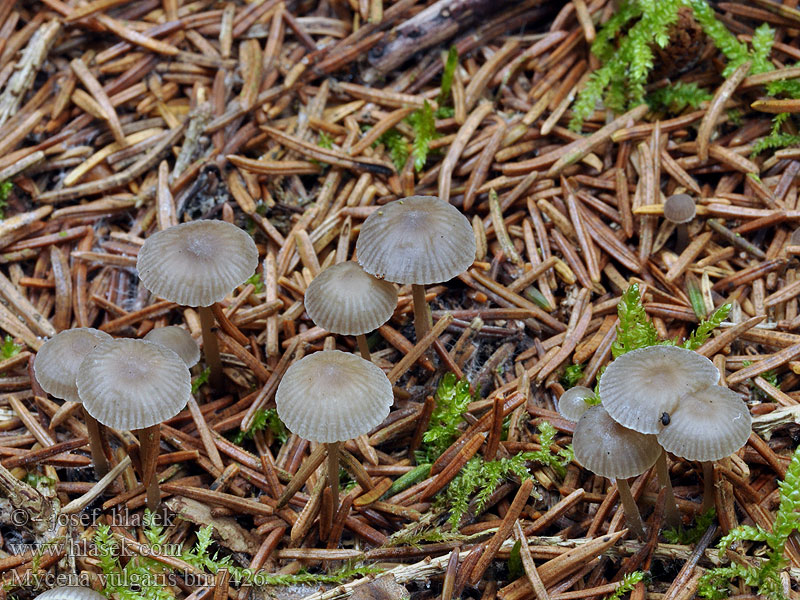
658,385,752,461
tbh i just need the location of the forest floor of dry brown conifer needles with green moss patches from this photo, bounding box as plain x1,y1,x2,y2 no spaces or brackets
0,0,800,600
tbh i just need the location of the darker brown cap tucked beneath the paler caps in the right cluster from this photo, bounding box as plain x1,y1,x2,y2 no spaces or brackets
572,405,661,479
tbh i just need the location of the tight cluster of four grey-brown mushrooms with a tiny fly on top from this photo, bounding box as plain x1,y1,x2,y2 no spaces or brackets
558,346,751,537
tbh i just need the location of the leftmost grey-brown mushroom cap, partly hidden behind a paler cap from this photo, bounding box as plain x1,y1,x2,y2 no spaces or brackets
33,327,113,402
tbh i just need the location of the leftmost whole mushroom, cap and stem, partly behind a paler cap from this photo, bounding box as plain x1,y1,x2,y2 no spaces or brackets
33,327,113,477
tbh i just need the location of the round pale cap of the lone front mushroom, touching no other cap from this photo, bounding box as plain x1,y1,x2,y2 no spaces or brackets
275,350,394,444
